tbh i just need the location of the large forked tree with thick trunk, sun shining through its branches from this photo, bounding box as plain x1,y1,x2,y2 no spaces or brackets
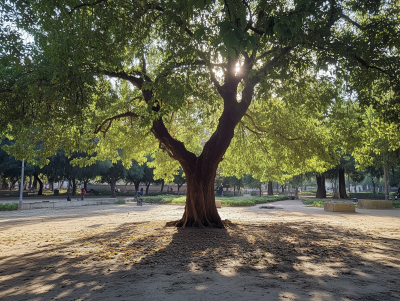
0,0,399,227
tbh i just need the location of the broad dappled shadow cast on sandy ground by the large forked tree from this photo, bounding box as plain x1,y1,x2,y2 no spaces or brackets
0,221,400,301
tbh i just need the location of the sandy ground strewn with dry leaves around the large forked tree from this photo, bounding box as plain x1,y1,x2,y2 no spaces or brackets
0,201,400,301
